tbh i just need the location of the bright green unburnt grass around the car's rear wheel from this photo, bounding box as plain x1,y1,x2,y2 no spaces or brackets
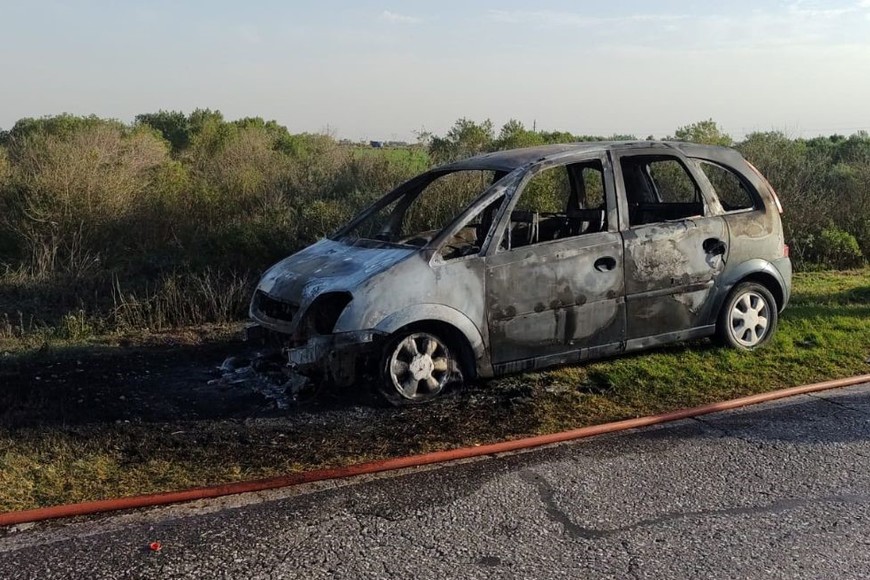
502,269,870,432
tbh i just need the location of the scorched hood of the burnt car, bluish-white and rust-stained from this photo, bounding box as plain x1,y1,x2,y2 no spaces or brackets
258,240,418,304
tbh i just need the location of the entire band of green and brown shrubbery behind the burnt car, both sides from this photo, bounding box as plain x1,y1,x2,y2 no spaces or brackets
0,109,870,334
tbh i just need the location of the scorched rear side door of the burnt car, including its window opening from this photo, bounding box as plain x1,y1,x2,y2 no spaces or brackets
614,147,728,348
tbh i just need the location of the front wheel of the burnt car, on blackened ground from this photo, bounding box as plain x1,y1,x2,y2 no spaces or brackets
378,330,462,407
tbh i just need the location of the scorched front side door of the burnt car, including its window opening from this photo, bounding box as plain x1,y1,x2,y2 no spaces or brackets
485,155,625,372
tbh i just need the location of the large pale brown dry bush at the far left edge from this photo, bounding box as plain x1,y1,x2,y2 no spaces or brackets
0,123,168,278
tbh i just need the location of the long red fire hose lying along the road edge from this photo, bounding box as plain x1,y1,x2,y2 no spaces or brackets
0,375,870,526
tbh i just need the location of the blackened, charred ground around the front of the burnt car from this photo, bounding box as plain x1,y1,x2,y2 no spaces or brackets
0,340,540,429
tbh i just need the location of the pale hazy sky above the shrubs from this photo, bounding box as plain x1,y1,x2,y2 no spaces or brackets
0,0,870,140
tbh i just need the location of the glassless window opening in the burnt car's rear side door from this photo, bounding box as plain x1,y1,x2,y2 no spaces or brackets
620,155,704,227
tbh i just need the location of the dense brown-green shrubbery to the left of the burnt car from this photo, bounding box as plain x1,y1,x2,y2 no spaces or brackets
0,110,427,335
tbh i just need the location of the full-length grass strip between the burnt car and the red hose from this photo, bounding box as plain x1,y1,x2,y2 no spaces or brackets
0,269,870,511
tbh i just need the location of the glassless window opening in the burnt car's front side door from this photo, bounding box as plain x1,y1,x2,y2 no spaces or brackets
501,159,607,250
